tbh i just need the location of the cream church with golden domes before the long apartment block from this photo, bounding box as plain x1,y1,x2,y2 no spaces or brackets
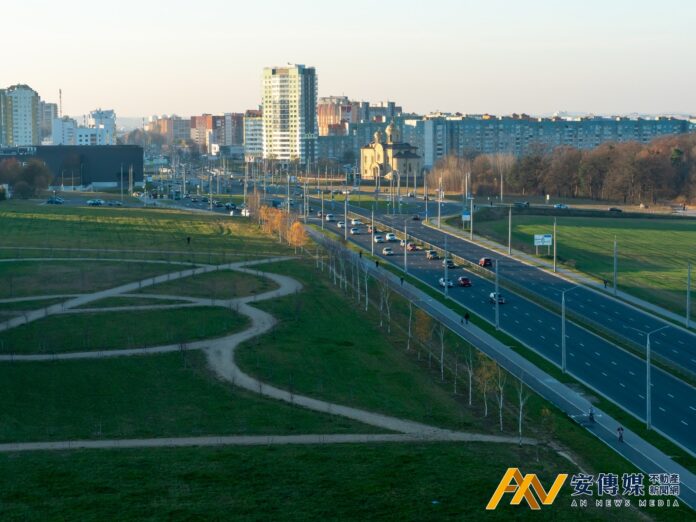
360,122,423,181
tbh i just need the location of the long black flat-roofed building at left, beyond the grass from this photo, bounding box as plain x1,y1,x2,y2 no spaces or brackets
0,145,143,186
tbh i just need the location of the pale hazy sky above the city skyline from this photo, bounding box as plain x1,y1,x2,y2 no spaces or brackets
5,0,696,116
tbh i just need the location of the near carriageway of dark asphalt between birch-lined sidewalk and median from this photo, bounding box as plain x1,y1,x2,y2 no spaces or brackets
314,208,696,453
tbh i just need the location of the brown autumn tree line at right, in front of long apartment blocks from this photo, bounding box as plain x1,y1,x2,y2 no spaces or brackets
429,134,696,204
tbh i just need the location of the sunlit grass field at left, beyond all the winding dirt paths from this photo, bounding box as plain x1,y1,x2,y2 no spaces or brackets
0,201,291,262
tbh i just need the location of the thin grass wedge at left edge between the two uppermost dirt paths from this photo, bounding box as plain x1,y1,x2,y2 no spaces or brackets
0,254,182,296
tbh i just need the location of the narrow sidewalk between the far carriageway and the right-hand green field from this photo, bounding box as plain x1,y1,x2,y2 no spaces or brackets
432,218,696,331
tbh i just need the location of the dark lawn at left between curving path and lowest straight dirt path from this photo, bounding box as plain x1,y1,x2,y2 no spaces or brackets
0,351,370,438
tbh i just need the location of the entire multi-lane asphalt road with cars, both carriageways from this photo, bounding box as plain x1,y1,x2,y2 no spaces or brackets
312,202,696,453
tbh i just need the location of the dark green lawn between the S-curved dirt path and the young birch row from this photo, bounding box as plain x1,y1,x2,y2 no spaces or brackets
237,261,474,429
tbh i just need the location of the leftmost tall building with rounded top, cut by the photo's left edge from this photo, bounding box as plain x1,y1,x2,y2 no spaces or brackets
0,84,41,147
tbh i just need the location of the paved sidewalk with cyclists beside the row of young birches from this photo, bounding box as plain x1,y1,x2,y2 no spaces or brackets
308,229,696,509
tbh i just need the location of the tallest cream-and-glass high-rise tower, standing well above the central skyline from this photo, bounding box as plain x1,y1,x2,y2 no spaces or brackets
263,65,318,164
